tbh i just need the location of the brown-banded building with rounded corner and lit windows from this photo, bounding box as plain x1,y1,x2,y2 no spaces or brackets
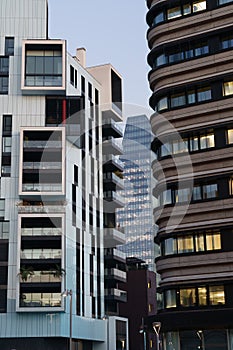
147,0,233,350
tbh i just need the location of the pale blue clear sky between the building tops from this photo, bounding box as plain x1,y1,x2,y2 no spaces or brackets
48,0,151,109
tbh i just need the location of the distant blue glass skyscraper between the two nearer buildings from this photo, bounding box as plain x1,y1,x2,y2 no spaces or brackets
117,115,155,271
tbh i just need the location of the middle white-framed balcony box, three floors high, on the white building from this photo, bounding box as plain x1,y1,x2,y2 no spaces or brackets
19,128,64,198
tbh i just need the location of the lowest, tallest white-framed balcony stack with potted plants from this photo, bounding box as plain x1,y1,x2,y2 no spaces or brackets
17,214,64,312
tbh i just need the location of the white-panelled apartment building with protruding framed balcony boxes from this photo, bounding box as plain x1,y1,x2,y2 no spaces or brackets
0,0,128,350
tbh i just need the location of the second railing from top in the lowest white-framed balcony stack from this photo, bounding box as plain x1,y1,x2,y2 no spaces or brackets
20,249,61,260
